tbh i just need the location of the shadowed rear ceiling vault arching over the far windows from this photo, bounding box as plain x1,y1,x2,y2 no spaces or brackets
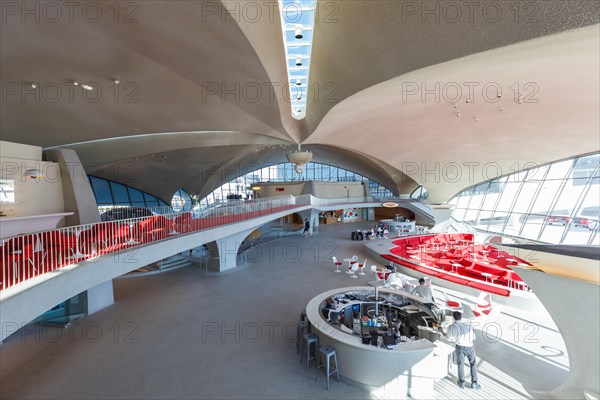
79,137,418,202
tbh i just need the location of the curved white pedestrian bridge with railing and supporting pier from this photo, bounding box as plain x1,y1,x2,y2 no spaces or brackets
0,195,434,340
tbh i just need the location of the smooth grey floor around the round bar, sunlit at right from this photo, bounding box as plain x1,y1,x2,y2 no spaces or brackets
0,223,568,399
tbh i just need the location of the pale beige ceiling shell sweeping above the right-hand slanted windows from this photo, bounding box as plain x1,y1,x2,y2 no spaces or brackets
307,26,600,202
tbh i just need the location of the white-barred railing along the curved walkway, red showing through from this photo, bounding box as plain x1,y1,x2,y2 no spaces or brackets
0,195,422,291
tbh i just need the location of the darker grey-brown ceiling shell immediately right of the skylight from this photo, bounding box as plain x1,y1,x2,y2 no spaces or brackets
307,0,600,134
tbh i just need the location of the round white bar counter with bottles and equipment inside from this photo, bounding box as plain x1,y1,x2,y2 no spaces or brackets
306,287,454,398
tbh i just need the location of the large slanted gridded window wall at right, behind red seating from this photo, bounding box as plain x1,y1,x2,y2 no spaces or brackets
449,153,600,245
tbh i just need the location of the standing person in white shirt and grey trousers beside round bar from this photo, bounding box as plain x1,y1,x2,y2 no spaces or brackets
443,311,481,389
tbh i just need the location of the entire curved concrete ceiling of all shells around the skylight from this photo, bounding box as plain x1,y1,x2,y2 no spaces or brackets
0,1,600,201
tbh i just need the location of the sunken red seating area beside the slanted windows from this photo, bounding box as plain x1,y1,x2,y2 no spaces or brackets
381,233,531,296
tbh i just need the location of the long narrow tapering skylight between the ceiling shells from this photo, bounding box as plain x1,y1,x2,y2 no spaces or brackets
279,0,317,119
